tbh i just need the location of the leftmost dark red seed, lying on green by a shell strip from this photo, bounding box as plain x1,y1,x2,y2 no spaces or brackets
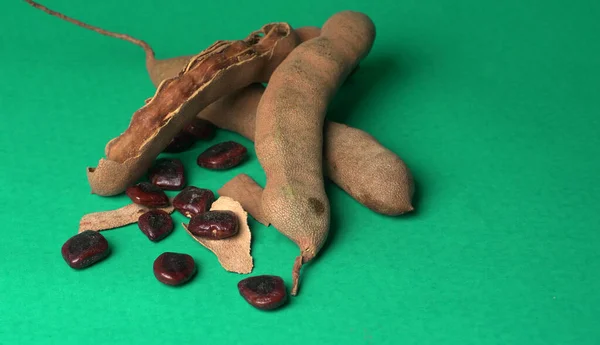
61,230,110,269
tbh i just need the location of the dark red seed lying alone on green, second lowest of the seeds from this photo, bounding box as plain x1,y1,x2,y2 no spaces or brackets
153,252,196,286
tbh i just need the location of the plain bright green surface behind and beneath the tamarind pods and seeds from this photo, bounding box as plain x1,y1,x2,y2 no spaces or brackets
0,0,600,345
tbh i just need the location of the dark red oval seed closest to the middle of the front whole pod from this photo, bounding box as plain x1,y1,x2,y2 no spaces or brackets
196,141,248,170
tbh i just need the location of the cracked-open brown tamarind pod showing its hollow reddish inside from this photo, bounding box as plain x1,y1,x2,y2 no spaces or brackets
88,23,297,196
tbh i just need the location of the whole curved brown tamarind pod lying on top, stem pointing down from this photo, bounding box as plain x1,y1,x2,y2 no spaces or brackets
255,11,375,295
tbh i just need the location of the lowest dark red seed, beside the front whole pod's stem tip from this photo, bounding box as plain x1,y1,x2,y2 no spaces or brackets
238,275,287,310
